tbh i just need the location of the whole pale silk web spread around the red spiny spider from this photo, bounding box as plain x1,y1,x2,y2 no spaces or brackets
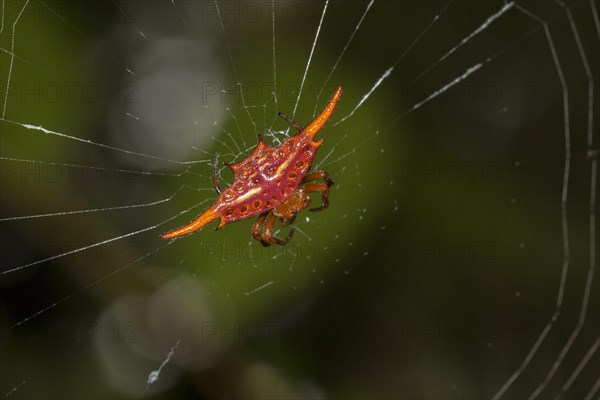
0,0,600,399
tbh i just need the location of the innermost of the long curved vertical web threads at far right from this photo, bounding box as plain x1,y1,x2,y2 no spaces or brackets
493,5,571,400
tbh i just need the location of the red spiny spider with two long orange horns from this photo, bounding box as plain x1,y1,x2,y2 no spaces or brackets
161,85,342,246
